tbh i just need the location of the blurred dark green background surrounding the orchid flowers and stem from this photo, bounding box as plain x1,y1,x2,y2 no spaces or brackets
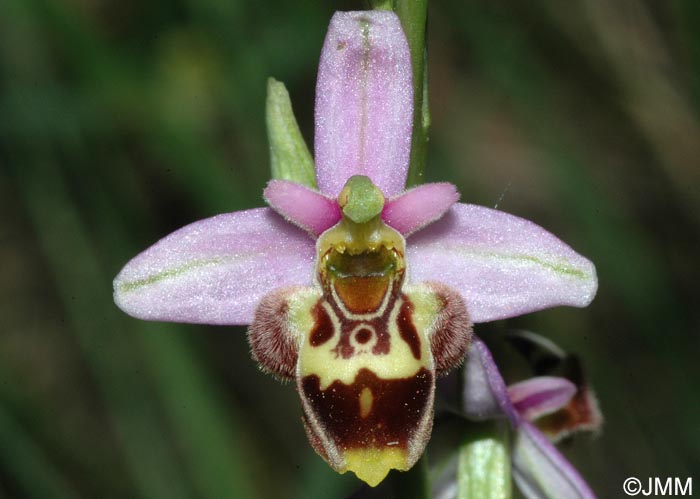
0,0,700,499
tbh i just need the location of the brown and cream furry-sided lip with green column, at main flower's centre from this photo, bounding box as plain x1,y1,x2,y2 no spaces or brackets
248,176,472,486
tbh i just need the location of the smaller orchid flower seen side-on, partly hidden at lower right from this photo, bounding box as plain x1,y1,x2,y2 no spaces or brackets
463,338,601,499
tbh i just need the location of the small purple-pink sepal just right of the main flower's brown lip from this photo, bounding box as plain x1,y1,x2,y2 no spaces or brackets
462,336,520,426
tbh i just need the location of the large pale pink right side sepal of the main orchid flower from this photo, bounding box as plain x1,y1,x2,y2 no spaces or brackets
407,203,598,323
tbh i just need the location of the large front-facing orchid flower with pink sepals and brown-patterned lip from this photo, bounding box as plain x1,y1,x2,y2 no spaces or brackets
114,11,597,486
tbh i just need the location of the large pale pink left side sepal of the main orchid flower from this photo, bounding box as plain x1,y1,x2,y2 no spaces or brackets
114,208,315,324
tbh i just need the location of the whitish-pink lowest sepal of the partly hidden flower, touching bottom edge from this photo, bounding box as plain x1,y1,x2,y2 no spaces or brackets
512,421,595,499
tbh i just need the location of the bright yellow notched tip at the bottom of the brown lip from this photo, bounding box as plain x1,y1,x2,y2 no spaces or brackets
345,447,410,487
